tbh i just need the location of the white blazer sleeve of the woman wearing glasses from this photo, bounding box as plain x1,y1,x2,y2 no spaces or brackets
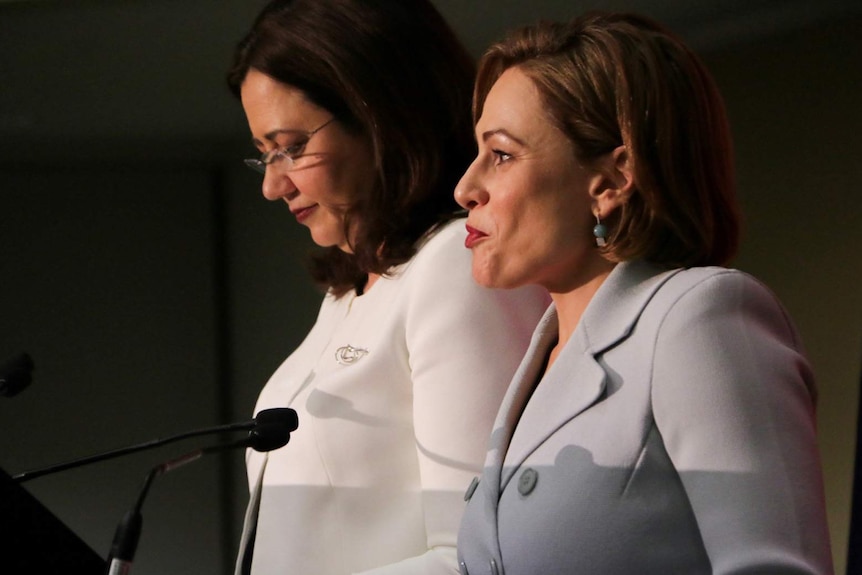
356,223,550,575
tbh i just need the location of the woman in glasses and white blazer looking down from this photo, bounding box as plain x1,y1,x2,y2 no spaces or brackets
229,0,548,575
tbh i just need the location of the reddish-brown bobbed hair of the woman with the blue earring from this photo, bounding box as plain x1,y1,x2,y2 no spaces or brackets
473,13,739,267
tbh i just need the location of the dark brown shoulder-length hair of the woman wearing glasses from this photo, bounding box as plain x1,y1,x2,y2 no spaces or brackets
228,0,475,295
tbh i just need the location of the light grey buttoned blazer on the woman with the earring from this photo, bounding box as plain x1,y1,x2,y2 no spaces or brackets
458,262,832,575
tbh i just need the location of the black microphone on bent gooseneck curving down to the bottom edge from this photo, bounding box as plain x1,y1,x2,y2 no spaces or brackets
103,416,297,575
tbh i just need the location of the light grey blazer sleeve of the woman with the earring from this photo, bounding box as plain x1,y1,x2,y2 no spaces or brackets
652,270,833,575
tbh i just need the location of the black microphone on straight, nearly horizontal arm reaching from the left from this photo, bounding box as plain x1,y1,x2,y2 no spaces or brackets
12,407,299,483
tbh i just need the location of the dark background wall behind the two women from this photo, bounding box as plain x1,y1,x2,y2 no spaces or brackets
0,0,862,575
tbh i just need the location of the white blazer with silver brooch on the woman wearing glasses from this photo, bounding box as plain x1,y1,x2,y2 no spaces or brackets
236,220,549,575
